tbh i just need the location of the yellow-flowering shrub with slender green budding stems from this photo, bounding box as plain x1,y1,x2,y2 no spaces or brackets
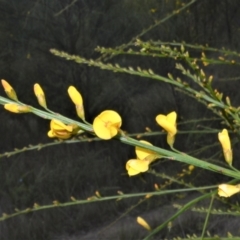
0,40,240,239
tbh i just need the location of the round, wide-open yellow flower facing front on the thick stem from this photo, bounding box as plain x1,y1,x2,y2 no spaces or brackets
93,110,122,140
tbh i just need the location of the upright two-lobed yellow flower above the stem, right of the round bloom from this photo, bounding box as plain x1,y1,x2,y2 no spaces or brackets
156,112,177,147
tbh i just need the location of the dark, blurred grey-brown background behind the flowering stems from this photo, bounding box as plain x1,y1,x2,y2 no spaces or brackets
0,0,240,240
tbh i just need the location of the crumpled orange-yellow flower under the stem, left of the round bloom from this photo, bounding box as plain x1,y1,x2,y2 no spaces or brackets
48,119,74,139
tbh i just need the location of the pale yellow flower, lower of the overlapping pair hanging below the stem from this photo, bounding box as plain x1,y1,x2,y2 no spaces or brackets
126,159,151,177
